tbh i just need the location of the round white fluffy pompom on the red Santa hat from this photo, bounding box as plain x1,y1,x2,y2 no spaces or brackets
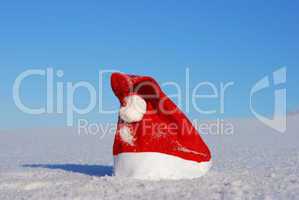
119,95,146,123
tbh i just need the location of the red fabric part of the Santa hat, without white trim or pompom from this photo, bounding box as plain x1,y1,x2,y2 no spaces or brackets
111,73,211,162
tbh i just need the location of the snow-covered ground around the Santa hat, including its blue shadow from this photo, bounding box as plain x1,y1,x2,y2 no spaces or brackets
0,115,299,200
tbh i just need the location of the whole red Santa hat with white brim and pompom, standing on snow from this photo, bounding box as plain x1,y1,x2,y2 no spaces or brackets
111,73,212,180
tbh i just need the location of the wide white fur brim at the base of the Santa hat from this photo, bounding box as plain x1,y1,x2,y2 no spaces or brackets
114,152,212,180
